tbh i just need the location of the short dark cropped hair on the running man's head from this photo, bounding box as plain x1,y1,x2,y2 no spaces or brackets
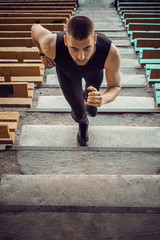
66,16,94,40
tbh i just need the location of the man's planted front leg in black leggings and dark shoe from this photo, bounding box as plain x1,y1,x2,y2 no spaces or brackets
56,67,89,146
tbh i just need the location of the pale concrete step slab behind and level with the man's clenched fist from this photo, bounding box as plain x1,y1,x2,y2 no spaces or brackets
37,96,155,112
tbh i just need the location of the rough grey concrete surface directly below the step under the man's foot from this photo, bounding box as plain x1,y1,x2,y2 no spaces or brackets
17,150,160,175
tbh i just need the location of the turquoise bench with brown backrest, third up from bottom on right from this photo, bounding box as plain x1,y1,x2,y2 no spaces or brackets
139,49,160,64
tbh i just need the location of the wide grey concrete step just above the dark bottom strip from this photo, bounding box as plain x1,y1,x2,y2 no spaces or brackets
0,174,160,213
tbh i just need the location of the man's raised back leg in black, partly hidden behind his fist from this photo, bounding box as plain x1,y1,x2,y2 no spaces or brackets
84,70,103,117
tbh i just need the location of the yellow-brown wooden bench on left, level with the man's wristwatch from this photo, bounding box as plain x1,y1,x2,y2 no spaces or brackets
0,48,41,63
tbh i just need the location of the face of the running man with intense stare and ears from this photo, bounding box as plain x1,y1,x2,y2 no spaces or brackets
64,34,97,66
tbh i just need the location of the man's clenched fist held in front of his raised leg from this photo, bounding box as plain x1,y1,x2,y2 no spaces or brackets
87,86,103,107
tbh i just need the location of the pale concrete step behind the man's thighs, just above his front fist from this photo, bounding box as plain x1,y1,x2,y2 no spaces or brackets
46,73,146,88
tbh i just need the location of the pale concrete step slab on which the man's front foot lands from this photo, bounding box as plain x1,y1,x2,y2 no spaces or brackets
19,125,160,149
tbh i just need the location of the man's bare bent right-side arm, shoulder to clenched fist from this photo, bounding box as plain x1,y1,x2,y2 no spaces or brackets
87,44,121,107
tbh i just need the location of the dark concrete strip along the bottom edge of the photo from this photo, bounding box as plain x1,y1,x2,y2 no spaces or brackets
0,212,160,240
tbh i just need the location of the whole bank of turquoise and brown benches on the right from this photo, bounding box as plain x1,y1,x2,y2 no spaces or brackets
117,0,160,106
